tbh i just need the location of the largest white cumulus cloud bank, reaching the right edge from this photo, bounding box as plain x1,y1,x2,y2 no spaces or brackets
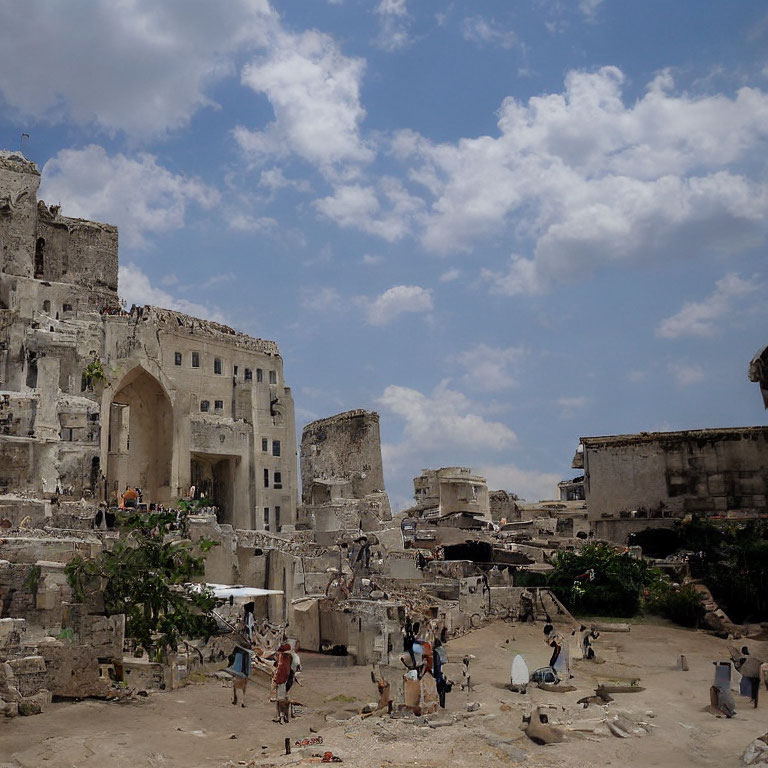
392,67,768,295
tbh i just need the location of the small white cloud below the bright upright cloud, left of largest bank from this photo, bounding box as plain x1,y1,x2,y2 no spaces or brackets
315,176,423,242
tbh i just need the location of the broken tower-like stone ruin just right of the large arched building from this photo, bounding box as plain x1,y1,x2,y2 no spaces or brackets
301,410,392,532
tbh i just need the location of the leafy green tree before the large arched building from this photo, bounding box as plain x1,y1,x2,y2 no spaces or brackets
66,512,216,652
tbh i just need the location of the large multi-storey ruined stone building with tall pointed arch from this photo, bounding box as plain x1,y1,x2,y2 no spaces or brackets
0,152,297,531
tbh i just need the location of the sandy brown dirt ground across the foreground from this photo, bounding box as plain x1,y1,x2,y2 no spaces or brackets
0,622,768,768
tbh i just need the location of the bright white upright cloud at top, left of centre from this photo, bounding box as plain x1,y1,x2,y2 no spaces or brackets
234,30,374,175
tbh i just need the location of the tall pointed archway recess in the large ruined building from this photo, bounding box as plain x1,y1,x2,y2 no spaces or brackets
107,366,173,504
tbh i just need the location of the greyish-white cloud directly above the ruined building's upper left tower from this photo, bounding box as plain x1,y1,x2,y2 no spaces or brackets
40,145,220,248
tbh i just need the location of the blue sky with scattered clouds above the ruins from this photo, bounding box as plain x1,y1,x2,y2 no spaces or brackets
0,0,768,507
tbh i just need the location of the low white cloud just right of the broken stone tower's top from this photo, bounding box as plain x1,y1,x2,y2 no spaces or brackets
378,382,517,462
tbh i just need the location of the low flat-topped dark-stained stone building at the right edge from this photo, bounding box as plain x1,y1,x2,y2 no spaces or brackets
573,427,768,543
